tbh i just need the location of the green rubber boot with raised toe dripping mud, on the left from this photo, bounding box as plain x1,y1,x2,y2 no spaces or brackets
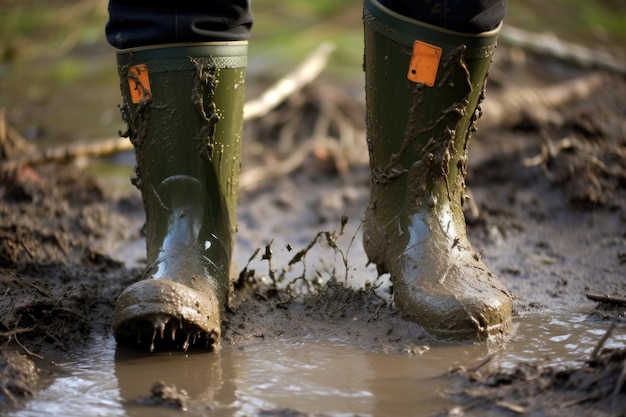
113,42,247,350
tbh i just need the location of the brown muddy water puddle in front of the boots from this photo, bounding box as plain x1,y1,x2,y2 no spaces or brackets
9,312,626,417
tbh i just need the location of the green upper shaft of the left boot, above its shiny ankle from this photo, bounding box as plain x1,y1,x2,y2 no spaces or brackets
117,42,247,240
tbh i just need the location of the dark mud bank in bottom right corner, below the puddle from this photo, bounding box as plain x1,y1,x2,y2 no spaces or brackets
446,336,626,416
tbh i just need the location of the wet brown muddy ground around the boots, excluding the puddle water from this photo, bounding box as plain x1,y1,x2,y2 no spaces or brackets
0,44,626,416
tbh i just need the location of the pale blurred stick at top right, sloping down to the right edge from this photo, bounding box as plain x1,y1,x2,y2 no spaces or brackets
499,25,626,75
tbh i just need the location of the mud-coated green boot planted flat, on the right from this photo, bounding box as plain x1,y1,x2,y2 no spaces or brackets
364,0,511,341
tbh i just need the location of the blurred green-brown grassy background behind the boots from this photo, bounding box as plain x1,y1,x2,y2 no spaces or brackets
0,0,626,159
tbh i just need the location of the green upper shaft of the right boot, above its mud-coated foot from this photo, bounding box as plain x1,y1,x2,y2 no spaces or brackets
363,0,499,208
